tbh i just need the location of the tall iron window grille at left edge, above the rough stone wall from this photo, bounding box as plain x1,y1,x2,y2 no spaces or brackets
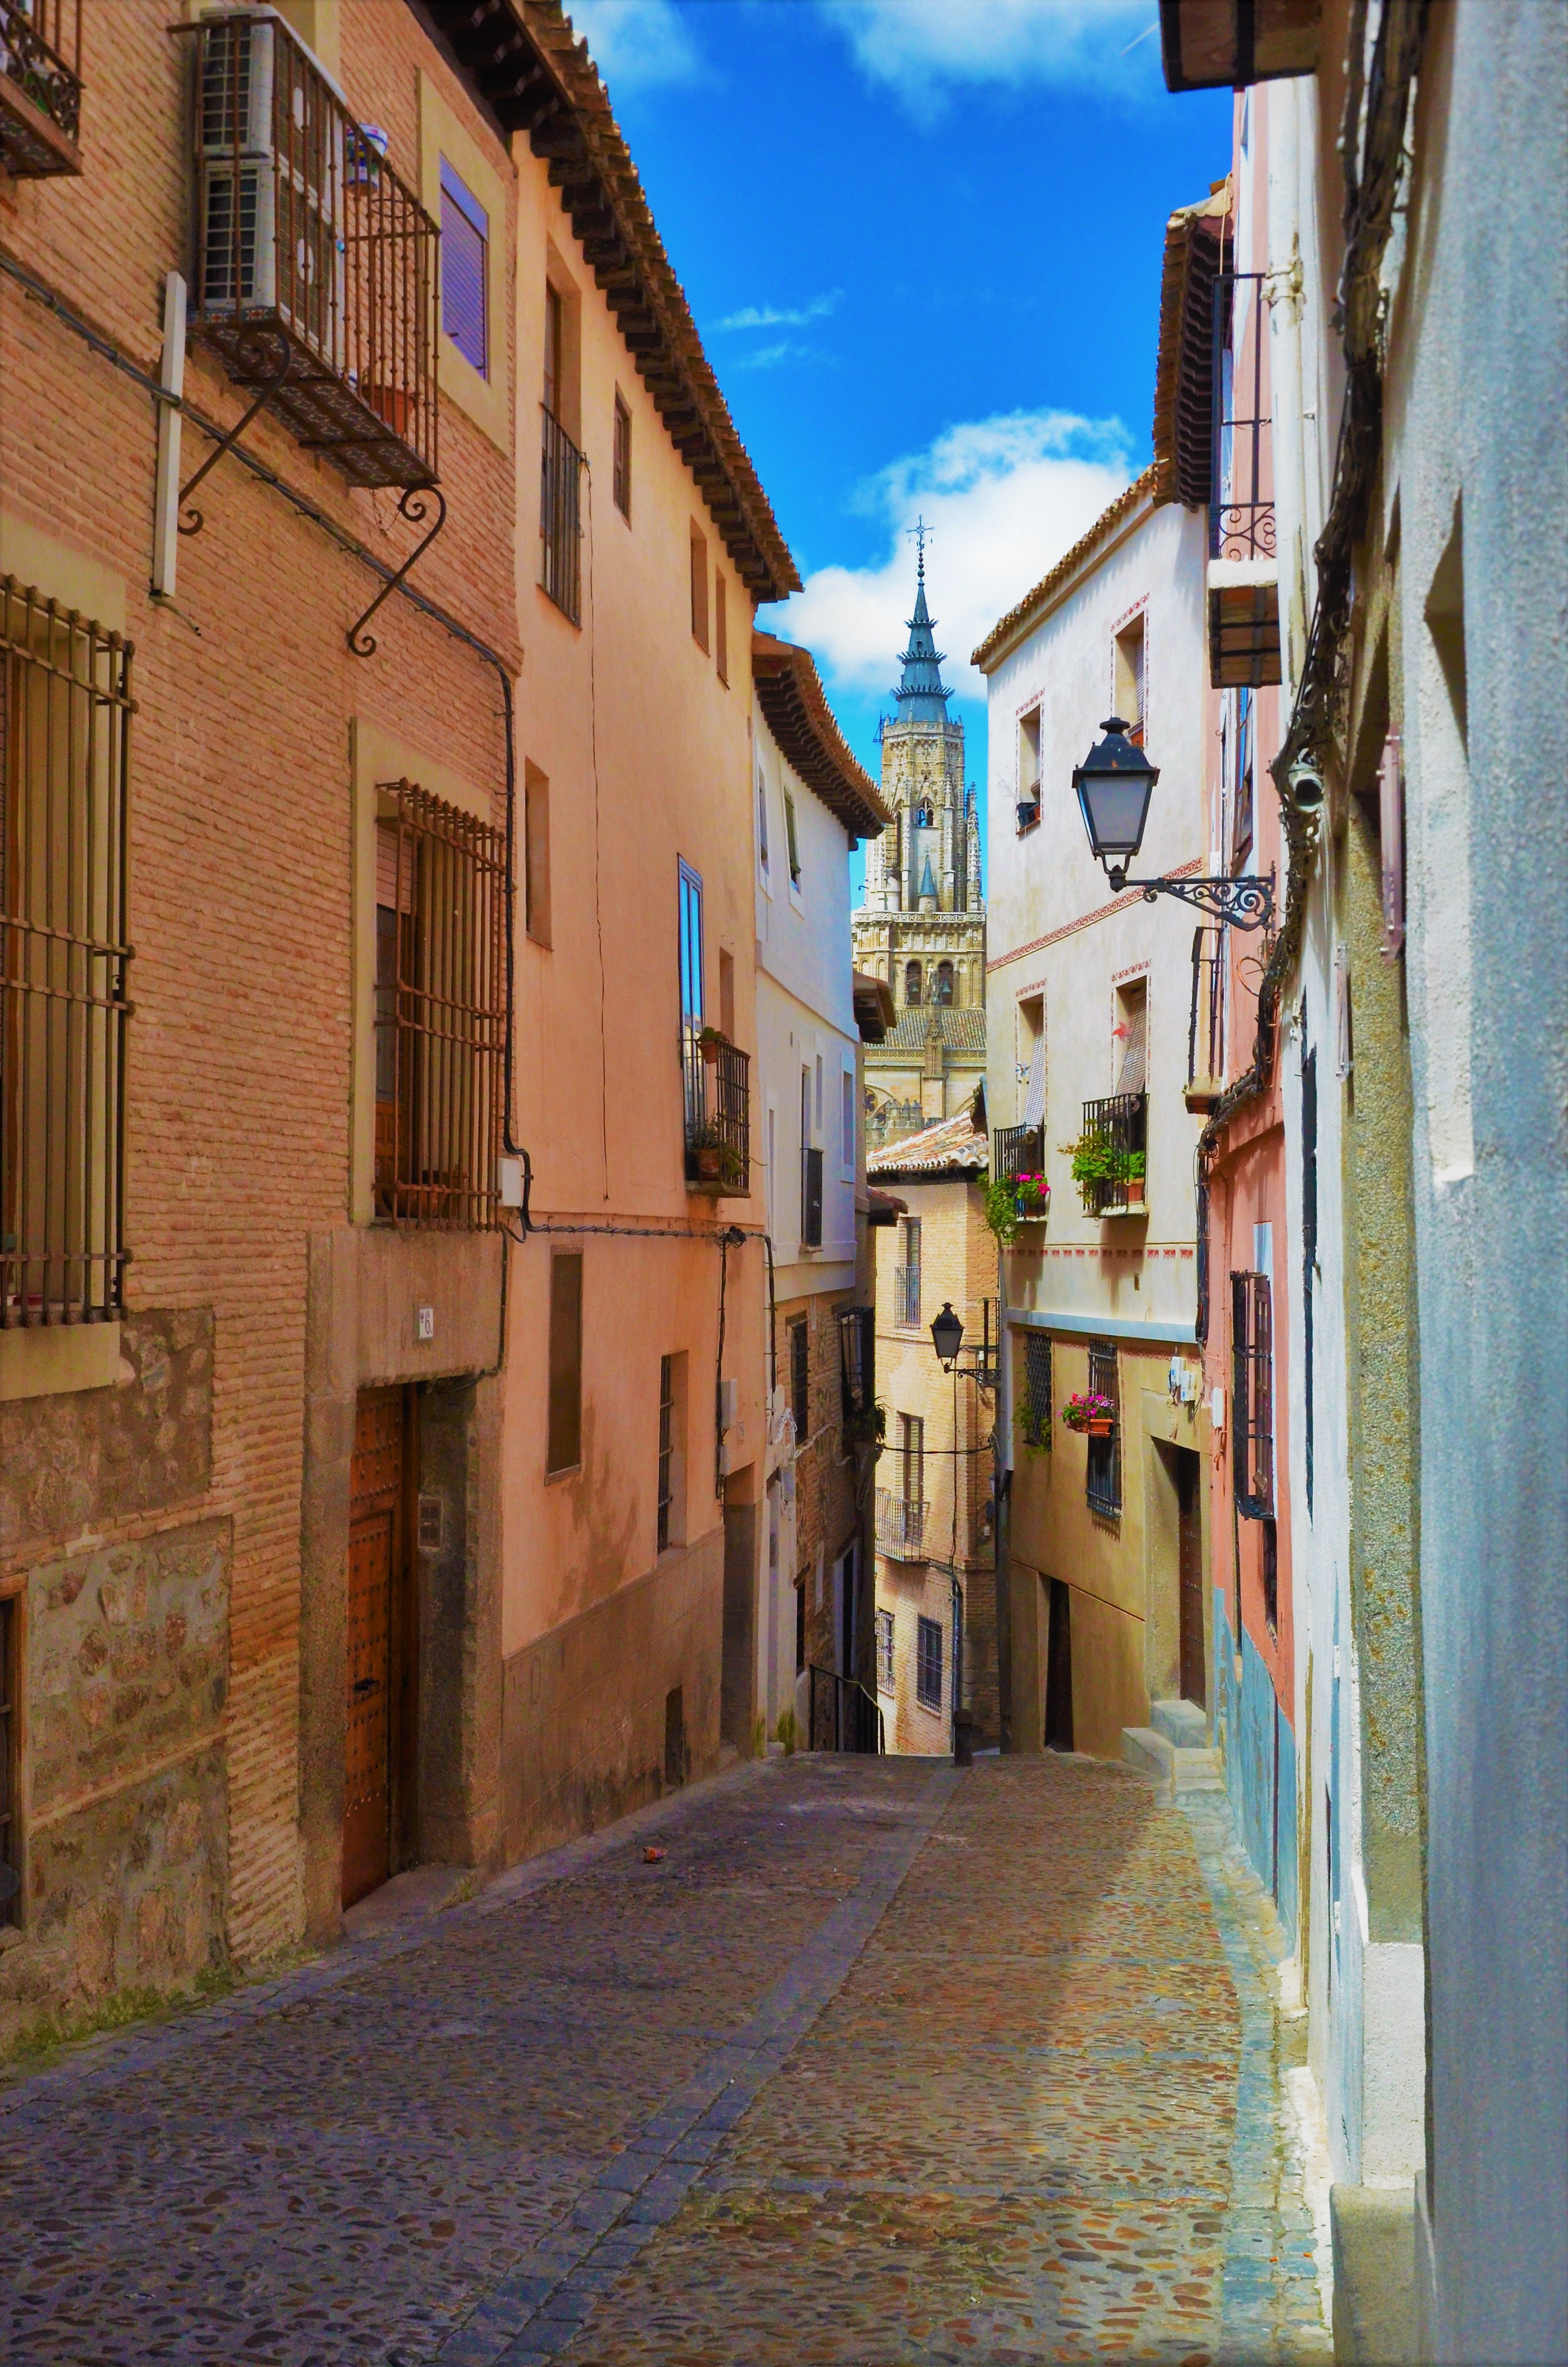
0,575,135,1330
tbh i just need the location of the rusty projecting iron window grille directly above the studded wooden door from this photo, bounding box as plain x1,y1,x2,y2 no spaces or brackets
376,781,506,1233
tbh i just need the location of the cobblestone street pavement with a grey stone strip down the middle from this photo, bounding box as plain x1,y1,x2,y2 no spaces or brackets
0,1759,1329,2367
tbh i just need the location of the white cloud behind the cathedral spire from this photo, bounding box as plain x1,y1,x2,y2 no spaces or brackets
768,412,1133,698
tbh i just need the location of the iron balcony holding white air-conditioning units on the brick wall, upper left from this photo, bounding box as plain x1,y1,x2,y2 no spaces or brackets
177,9,440,488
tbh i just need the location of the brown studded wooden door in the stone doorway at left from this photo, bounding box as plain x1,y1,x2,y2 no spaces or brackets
343,1389,404,1908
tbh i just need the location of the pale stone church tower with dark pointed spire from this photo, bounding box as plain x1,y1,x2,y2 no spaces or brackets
852,549,986,1151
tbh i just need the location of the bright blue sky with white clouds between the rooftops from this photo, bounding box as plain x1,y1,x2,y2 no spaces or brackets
572,0,1230,871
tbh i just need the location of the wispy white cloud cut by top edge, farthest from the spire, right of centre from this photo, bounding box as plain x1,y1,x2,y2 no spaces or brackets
818,0,1159,121
